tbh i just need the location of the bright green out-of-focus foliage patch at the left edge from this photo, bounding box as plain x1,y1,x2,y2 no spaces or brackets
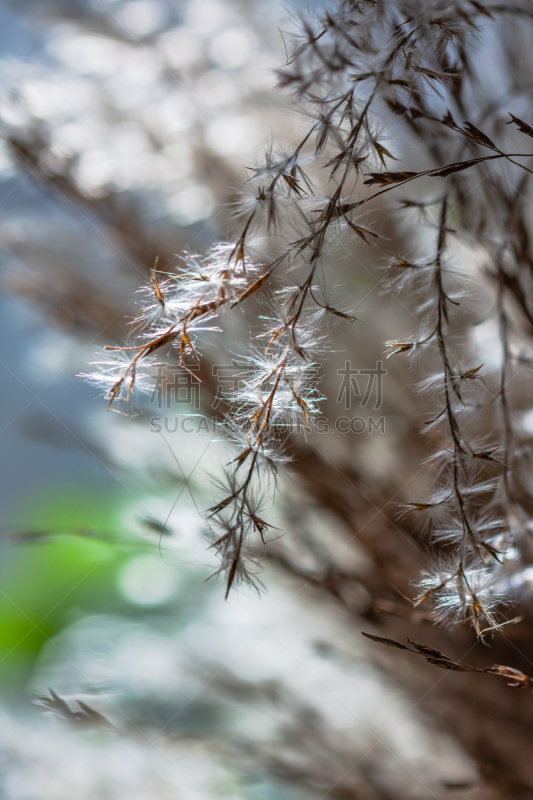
0,483,127,693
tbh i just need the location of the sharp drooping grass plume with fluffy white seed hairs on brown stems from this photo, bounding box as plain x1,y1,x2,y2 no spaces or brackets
80,0,533,612
